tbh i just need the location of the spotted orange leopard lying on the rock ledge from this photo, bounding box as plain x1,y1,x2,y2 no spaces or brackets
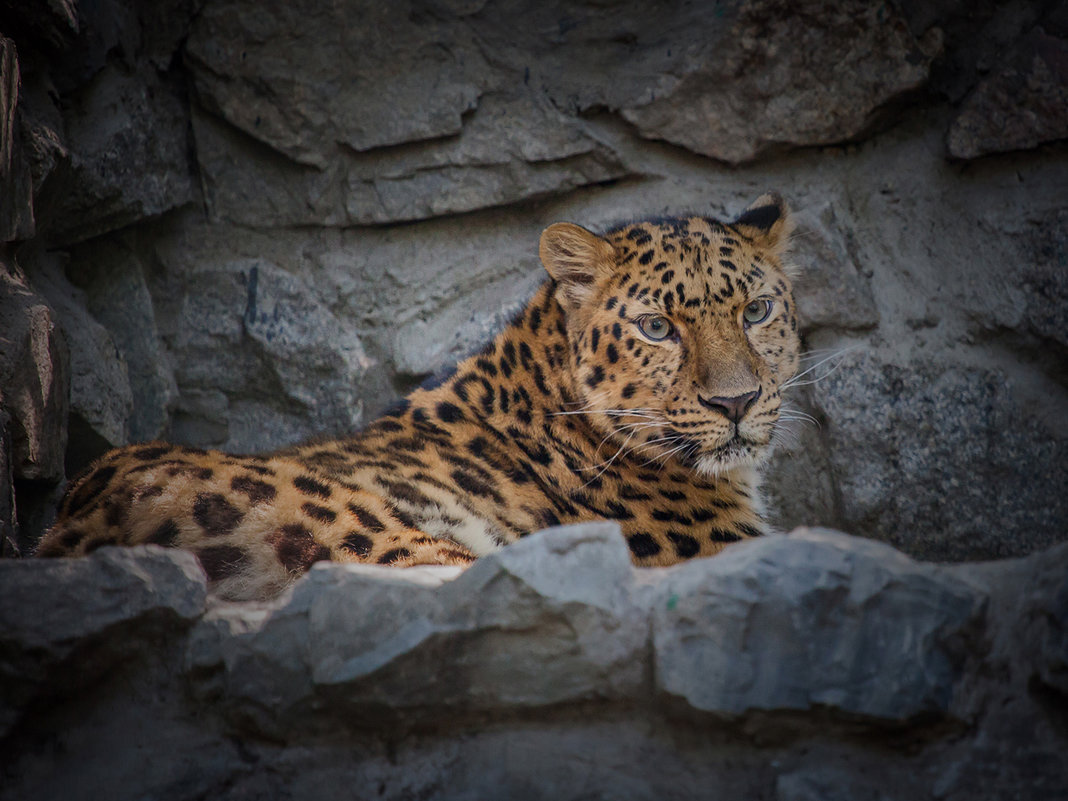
36,193,801,600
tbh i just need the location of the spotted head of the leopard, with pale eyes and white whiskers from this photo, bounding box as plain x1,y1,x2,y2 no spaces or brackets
540,194,800,474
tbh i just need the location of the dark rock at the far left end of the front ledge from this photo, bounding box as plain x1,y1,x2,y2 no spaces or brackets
0,546,206,735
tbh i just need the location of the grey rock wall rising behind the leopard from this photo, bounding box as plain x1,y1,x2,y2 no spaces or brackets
0,0,1068,560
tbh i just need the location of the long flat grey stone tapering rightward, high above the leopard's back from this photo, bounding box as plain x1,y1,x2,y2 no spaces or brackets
193,90,626,227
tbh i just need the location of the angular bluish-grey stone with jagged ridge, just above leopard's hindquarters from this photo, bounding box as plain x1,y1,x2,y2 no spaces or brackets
144,244,372,451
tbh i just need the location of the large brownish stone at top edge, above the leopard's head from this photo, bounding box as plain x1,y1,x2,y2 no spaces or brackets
623,0,941,163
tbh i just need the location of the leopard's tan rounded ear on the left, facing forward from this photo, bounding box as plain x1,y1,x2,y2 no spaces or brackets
538,222,616,312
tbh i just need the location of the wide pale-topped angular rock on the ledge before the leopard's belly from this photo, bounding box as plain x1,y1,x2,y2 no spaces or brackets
190,523,647,734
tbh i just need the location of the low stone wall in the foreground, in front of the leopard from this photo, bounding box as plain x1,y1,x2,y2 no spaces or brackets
0,523,1068,801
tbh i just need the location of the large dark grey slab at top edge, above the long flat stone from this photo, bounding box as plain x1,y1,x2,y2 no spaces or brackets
186,0,487,163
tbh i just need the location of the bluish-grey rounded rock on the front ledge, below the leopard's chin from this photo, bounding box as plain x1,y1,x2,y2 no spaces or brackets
653,529,983,724
